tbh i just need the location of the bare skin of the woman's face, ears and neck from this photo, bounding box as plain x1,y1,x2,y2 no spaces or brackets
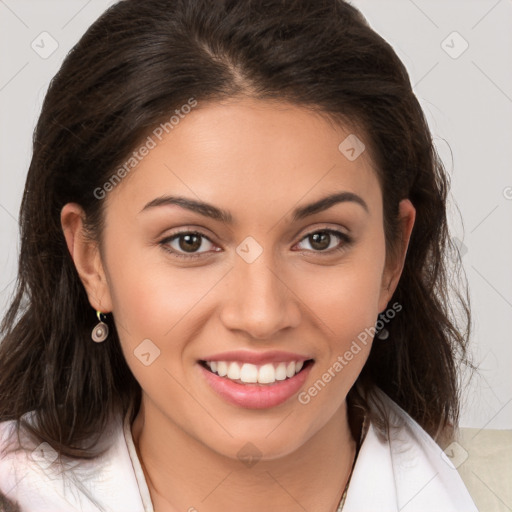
61,98,415,512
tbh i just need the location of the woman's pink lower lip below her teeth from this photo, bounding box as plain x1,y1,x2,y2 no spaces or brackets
198,362,313,409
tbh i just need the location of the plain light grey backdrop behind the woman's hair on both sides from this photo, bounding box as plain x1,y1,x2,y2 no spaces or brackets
0,0,512,429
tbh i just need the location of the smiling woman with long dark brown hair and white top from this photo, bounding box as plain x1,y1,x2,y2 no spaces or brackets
0,0,476,512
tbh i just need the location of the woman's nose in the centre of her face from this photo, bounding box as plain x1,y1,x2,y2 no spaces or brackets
221,251,301,340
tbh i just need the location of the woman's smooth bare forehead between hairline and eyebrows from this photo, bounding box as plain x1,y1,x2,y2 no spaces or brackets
104,99,380,222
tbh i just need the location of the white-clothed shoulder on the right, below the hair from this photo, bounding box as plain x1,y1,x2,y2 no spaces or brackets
345,390,477,512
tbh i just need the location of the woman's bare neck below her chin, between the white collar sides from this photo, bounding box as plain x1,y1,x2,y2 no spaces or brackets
132,400,356,512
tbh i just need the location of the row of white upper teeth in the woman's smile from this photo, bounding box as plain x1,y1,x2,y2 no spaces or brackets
206,361,304,384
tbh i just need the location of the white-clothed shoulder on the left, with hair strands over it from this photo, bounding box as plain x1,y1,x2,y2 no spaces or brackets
0,418,143,512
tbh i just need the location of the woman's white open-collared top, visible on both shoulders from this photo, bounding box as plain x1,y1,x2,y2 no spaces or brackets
0,391,478,512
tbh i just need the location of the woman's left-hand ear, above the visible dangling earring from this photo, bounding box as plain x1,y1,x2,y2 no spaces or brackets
60,203,112,313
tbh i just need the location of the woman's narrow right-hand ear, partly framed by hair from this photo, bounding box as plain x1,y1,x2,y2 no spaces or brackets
379,199,416,312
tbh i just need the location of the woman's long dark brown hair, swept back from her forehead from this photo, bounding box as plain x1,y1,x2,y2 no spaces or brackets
0,0,470,457
